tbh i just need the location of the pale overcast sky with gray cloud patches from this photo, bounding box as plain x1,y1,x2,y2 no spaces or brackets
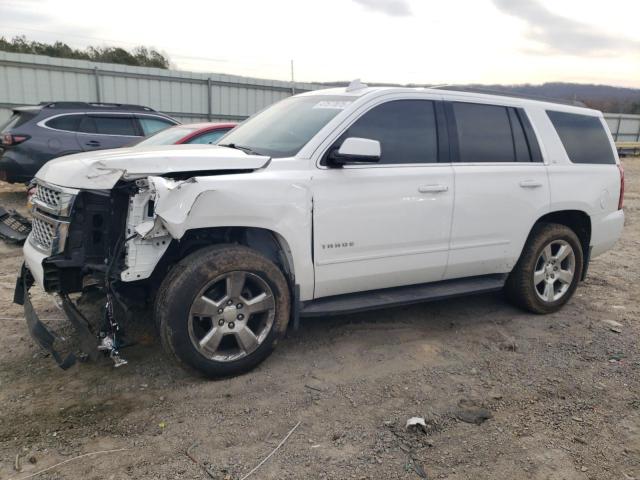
0,0,640,87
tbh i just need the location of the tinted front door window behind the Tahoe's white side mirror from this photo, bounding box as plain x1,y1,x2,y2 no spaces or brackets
337,100,438,164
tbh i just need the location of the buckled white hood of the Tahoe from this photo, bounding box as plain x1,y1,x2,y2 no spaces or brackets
36,145,270,189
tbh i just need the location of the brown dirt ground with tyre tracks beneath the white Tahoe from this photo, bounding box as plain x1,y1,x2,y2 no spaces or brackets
0,158,640,480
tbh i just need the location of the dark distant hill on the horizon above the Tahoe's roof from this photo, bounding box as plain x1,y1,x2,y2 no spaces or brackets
324,82,640,114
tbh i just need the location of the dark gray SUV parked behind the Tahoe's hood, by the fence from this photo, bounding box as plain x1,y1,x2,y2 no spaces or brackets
0,102,179,183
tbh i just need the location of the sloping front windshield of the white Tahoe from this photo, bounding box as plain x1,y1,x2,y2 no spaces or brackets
218,95,356,158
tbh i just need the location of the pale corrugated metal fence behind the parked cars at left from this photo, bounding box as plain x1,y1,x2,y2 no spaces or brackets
0,52,323,123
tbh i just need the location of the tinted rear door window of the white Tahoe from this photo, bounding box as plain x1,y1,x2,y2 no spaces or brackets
452,102,541,163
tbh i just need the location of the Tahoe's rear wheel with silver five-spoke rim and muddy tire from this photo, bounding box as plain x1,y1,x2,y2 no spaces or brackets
505,223,584,314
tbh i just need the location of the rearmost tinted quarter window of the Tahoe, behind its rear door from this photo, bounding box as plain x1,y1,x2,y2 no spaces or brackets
547,110,616,164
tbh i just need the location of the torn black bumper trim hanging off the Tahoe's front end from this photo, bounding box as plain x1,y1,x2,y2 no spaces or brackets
13,264,99,370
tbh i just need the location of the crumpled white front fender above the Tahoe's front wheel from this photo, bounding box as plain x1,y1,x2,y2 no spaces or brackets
121,167,313,298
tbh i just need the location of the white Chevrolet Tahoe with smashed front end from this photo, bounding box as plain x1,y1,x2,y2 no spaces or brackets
15,83,624,377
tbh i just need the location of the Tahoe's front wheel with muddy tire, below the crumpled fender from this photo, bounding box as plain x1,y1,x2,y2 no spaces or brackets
155,245,290,378
